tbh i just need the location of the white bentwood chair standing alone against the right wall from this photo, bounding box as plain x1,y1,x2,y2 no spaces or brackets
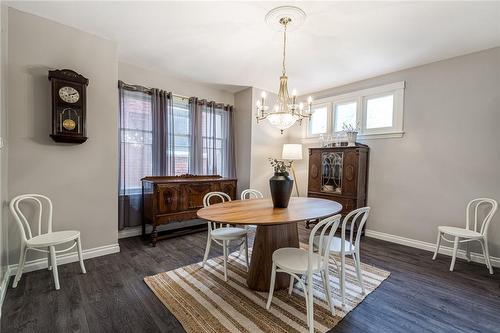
432,198,498,274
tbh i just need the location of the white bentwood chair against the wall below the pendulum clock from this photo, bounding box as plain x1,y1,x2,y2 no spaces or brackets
9,194,87,290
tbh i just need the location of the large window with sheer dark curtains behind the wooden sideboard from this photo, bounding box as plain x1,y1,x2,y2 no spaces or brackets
118,81,236,229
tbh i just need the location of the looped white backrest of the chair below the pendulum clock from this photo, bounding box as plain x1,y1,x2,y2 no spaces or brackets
9,194,52,242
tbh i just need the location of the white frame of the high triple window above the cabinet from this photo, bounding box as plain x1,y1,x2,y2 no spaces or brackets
305,81,406,139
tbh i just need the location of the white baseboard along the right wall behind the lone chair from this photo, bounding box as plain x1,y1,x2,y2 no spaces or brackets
365,229,500,267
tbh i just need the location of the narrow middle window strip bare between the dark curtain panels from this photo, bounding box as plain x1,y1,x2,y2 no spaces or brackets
173,97,191,175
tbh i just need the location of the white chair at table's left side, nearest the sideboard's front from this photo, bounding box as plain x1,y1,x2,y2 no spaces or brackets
202,192,249,281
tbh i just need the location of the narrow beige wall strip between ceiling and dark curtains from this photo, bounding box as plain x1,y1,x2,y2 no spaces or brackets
118,62,234,105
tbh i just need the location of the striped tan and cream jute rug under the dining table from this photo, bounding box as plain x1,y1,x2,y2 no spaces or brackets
144,245,390,333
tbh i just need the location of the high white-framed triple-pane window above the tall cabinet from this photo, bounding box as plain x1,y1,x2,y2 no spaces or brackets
307,81,405,139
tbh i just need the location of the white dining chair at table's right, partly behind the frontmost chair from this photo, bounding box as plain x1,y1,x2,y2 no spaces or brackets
314,207,370,306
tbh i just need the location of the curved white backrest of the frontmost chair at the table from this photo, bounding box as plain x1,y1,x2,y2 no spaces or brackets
308,214,342,271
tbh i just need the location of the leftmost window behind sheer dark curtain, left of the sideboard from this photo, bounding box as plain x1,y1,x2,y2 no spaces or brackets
120,90,153,194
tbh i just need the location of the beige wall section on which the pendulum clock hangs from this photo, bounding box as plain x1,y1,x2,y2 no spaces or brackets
8,9,118,264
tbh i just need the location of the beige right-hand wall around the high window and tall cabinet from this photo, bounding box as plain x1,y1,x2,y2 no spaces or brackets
289,48,500,257
